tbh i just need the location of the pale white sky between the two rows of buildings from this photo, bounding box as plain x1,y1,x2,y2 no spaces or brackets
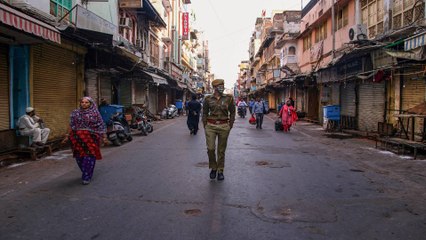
188,0,302,88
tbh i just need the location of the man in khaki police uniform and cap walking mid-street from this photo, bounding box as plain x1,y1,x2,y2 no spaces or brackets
203,79,235,181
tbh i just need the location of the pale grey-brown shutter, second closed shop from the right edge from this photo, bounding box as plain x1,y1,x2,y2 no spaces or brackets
358,81,385,132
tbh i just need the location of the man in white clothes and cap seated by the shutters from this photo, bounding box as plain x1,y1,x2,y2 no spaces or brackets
18,107,50,147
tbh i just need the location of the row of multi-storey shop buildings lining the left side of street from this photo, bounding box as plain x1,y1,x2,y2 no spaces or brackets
0,0,208,153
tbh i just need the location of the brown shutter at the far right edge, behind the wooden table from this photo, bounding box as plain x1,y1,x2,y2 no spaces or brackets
402,73,426,136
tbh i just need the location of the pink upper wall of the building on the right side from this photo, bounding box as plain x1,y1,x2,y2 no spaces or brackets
297,0,355,73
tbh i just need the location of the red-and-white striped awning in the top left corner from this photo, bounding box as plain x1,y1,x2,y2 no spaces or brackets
0,3,61,44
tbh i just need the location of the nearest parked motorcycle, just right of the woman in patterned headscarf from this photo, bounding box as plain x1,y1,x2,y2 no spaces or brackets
107,113,133,146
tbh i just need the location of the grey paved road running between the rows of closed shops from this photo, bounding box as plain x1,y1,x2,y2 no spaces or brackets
0,116,426,240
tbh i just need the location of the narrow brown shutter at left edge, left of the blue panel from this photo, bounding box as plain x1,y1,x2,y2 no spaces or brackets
0,44,10,131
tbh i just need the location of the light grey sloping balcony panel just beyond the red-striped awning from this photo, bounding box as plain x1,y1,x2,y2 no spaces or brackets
75,5,118,35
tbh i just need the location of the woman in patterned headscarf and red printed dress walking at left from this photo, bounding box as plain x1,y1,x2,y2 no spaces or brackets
64,97,107,185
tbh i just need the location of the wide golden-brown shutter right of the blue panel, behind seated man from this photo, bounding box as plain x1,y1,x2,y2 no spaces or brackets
33,44,77,138
